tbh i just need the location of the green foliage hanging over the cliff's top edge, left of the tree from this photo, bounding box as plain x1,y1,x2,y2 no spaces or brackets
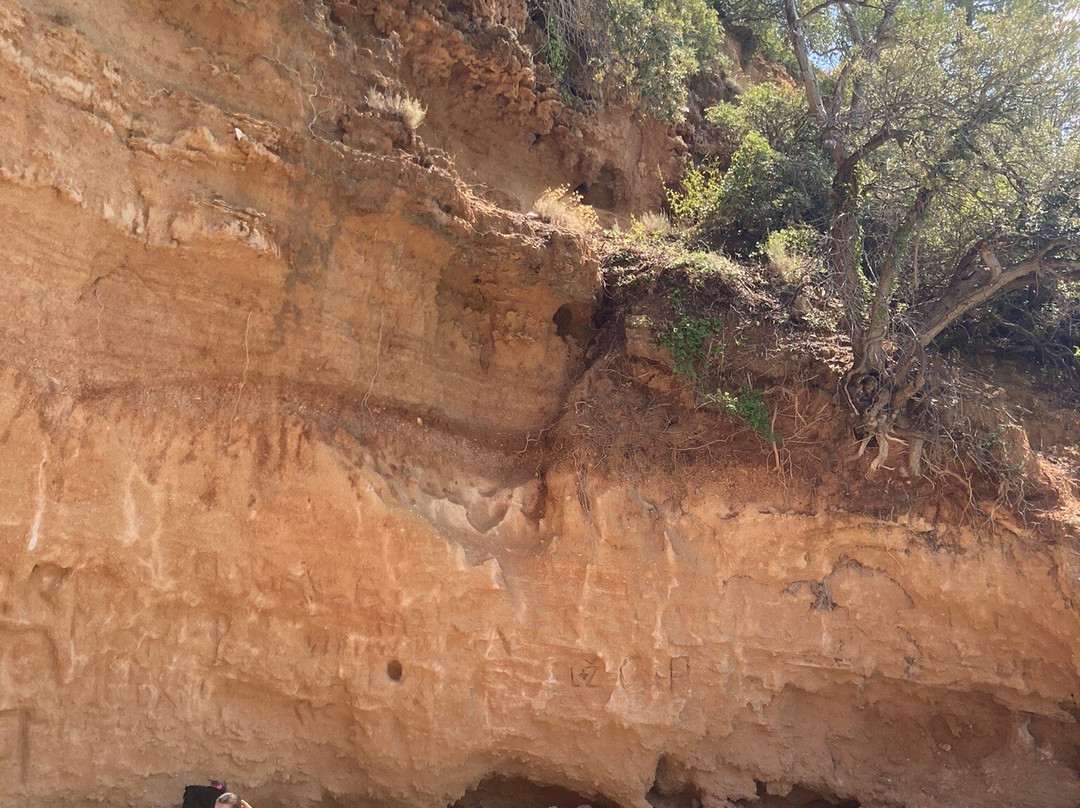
529,0,724,121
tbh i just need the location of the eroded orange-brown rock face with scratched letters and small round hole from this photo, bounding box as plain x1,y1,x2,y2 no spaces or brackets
0,0,1080,808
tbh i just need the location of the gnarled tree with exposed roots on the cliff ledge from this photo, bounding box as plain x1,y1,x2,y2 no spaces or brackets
777,0,1080,462
